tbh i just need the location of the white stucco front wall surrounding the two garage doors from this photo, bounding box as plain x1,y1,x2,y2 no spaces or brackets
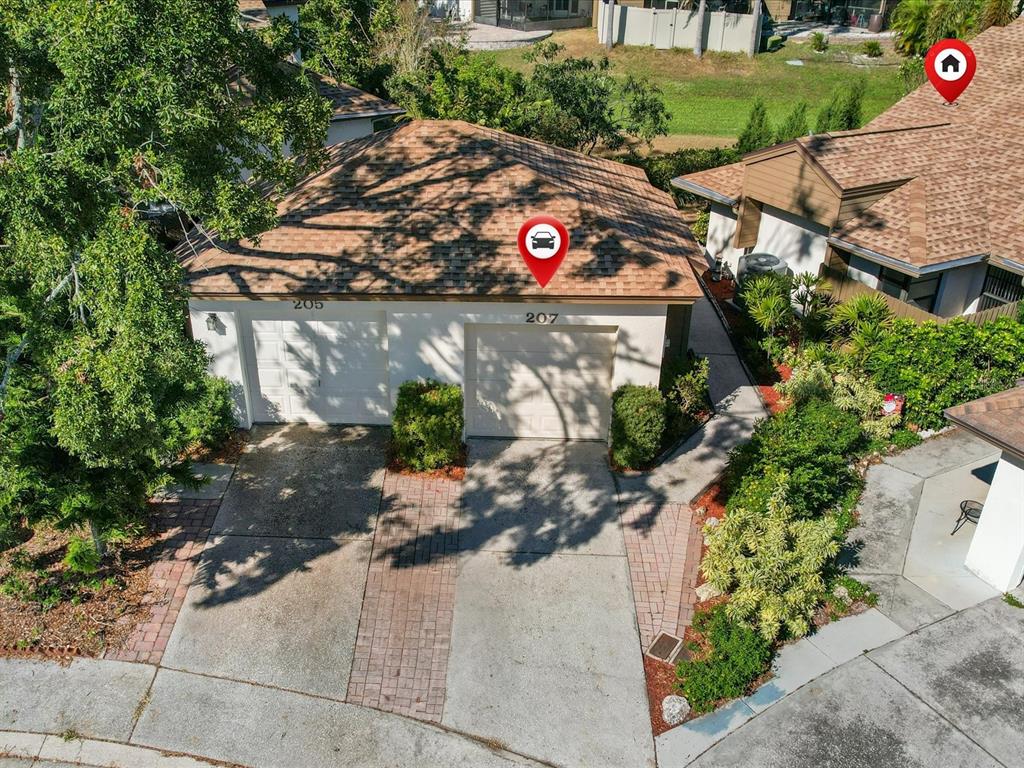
189,299,667,434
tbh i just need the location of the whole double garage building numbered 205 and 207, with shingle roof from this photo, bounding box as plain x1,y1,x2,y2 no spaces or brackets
178,121,700,439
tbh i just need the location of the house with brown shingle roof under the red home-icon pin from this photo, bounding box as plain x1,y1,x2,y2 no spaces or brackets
673,19,1024,317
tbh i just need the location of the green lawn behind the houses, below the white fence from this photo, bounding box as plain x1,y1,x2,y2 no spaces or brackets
483,29,902,148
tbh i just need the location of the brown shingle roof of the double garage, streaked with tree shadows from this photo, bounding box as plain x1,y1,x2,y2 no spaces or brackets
179,121,700,301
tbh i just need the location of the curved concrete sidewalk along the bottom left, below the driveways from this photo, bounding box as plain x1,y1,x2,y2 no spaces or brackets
0,658,544,768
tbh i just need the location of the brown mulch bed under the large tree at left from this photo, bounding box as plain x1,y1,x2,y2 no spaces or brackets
0,526,158,659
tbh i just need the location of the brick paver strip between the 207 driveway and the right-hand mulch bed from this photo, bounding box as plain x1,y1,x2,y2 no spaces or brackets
620,504,701,651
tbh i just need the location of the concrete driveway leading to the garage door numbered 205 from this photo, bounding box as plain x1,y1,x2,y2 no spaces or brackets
163,425,385,700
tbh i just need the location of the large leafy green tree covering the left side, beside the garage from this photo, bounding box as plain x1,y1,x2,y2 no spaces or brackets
0,0,329,548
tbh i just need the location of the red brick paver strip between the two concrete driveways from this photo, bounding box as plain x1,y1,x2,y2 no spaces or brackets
346,471,462,722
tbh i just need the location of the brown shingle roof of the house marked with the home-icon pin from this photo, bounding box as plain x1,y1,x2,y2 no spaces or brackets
671,18,1024,272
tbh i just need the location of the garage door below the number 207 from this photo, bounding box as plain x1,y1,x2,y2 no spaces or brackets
466,326,615,439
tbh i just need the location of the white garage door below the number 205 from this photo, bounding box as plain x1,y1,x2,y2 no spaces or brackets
252,318,388,424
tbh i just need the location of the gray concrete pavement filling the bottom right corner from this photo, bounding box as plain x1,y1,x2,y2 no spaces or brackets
657,590,1024,768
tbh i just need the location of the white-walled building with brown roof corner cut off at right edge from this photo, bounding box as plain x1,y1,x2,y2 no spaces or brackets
946,380,1024,592
